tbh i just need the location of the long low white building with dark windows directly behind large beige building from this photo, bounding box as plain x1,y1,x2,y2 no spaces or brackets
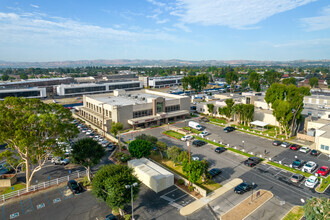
56,81,142,96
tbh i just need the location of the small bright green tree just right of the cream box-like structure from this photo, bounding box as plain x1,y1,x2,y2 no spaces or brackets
182,159,205,183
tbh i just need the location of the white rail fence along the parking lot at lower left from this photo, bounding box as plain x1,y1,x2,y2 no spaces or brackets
1,170,87,202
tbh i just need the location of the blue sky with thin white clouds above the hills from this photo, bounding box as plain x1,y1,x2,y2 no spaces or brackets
0,0,330,62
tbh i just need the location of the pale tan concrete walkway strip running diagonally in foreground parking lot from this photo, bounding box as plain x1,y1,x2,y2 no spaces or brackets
180,178,243,216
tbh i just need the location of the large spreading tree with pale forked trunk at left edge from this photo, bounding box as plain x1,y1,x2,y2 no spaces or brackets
0,97,79,188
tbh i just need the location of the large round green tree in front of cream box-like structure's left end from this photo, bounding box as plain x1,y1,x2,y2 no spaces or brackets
92,164,141,209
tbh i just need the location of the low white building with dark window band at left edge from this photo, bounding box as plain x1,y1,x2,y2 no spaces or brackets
0,87,47,100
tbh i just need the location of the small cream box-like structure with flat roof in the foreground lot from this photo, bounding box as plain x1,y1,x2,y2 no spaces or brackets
127,158,174,193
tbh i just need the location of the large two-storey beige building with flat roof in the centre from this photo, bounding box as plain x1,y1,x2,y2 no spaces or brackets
77,89,190,132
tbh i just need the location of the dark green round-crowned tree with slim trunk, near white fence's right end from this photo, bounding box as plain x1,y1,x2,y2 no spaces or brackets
71,138,105,182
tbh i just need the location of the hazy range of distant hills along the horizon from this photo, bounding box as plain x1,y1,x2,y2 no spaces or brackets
0,59,330,68
